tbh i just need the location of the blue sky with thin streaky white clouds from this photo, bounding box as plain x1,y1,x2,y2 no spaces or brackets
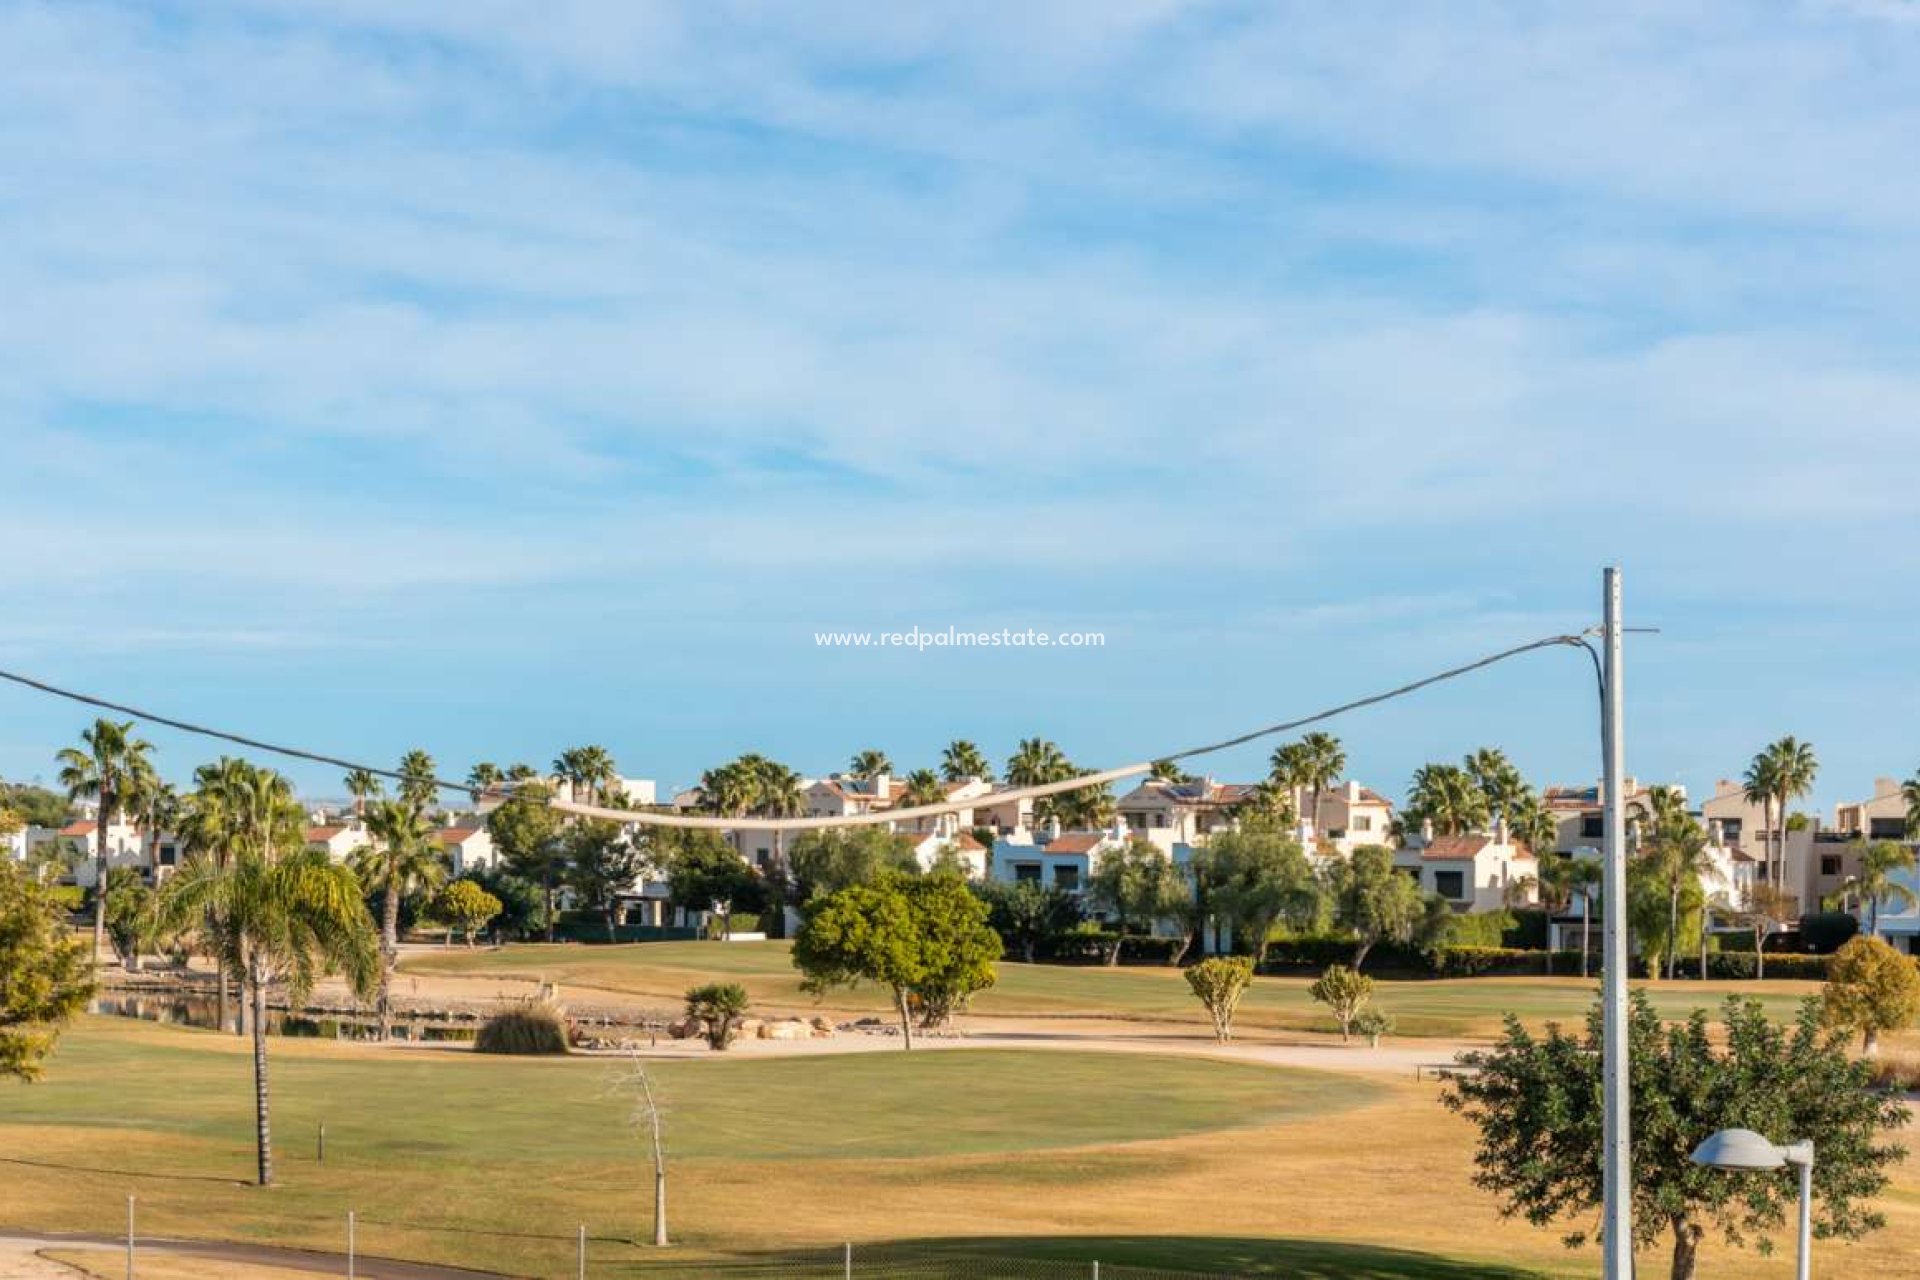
0,0,1920,804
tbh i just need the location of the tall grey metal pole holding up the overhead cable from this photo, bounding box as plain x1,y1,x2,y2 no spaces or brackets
1599,568,1634,1280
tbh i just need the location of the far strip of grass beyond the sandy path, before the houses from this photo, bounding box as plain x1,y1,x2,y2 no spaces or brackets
403,942,1818,1036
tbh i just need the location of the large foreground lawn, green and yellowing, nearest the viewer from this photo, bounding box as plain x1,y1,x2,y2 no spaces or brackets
0,1017,1920,1280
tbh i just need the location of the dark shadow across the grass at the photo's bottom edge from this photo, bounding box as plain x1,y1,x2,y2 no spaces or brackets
634,1236,1544,1280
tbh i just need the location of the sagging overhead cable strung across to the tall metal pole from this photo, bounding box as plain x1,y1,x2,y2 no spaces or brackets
0,635,1597,831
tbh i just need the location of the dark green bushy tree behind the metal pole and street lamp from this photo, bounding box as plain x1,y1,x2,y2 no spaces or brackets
1446,992,1908,1280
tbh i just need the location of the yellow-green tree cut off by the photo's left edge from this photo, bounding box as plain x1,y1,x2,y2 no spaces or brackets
0,858,94,1080
